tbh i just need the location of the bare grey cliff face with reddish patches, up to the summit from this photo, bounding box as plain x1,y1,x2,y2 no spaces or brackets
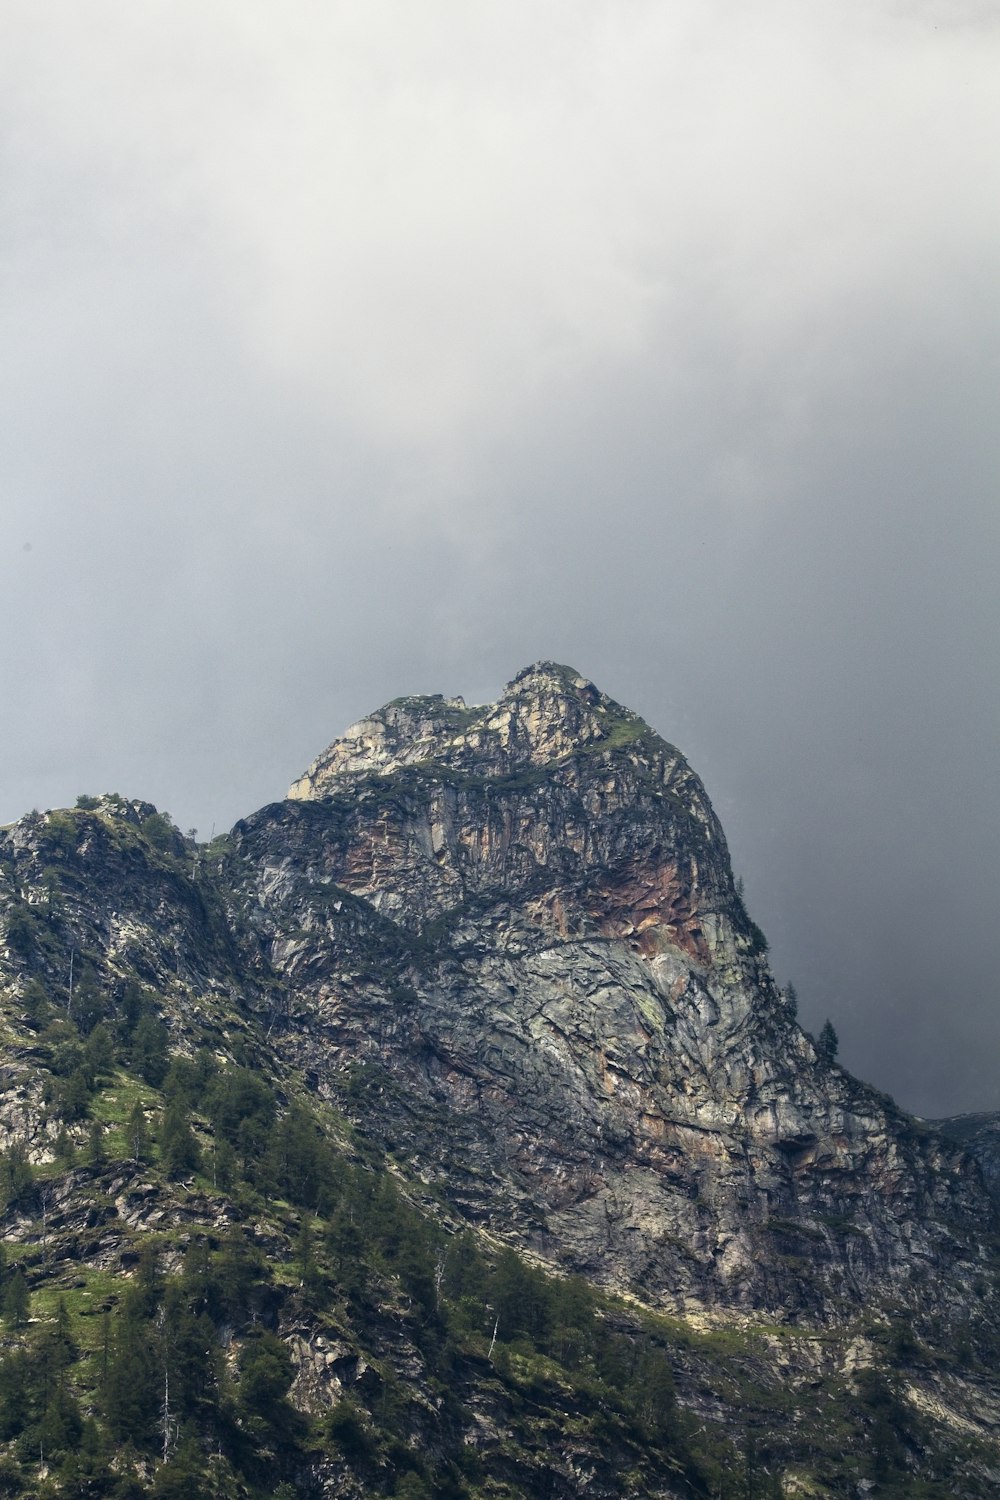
223,663,993,1317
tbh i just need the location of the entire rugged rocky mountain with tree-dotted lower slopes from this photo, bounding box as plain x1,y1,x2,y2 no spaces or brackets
0,663,1000,1497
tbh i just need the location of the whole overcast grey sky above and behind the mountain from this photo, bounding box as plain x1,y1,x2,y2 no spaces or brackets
0,0,1000,1115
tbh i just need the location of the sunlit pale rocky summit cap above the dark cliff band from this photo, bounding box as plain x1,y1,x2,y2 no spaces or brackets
288,662,646,801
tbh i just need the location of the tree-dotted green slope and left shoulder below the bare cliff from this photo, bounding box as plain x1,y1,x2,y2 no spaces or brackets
0,797,722,1500
